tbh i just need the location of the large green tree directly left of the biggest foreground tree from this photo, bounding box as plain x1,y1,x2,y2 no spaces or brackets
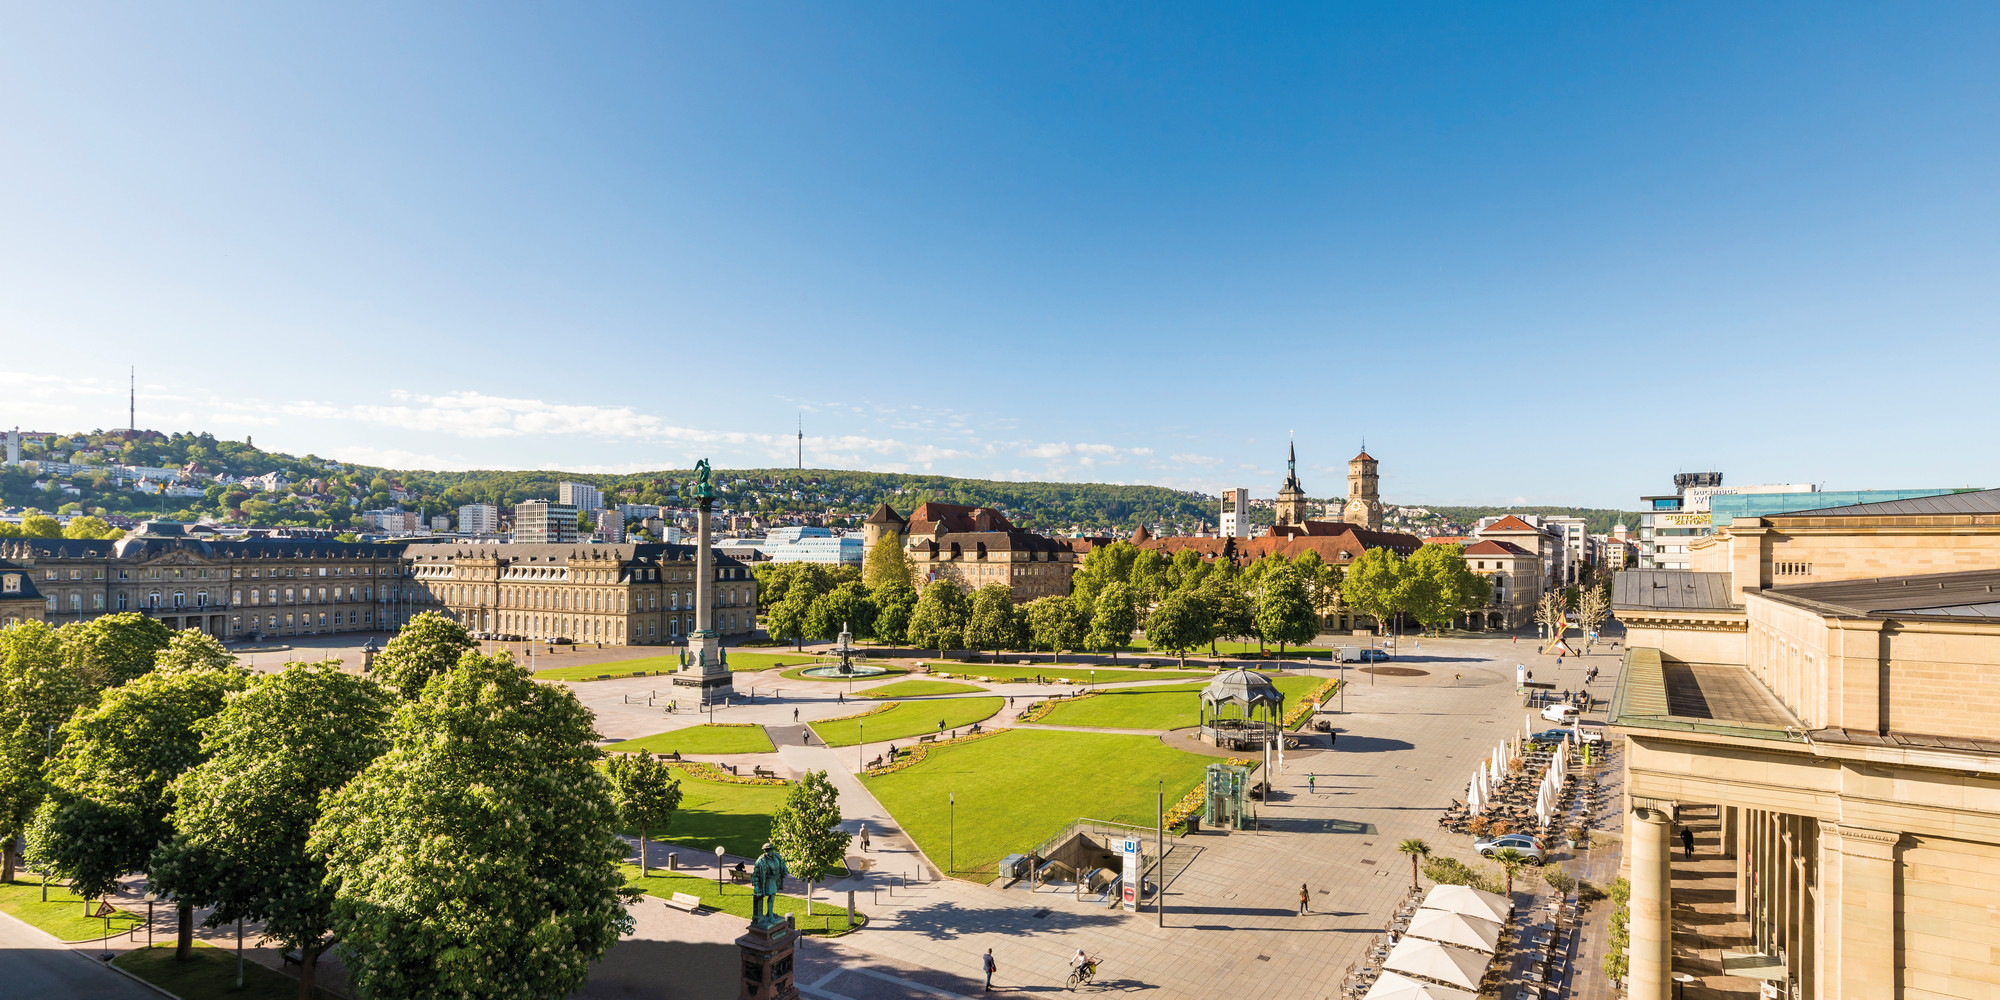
152,660,398,1000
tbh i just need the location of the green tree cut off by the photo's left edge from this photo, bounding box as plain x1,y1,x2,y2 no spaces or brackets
0,622,96,882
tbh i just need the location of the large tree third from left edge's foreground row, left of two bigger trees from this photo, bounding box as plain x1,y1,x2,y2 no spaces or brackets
28,666,250,954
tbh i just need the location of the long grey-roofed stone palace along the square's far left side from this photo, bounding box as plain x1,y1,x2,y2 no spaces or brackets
0,522,756,646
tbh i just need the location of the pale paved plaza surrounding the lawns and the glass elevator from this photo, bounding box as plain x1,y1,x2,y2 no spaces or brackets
572,638,1618,1000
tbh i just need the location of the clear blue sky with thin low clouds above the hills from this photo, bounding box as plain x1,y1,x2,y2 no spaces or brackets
0,2,2000,506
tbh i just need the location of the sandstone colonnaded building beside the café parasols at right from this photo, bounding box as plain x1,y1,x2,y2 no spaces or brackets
1610,490,2000,1000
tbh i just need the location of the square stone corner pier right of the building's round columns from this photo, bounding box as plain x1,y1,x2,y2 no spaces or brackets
1820,826,1902,996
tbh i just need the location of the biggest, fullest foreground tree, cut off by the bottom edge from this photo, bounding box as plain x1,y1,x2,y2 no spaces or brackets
308,654,636,1000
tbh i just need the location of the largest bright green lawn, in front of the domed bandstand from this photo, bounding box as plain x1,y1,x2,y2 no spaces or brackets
864,730,1216,882
